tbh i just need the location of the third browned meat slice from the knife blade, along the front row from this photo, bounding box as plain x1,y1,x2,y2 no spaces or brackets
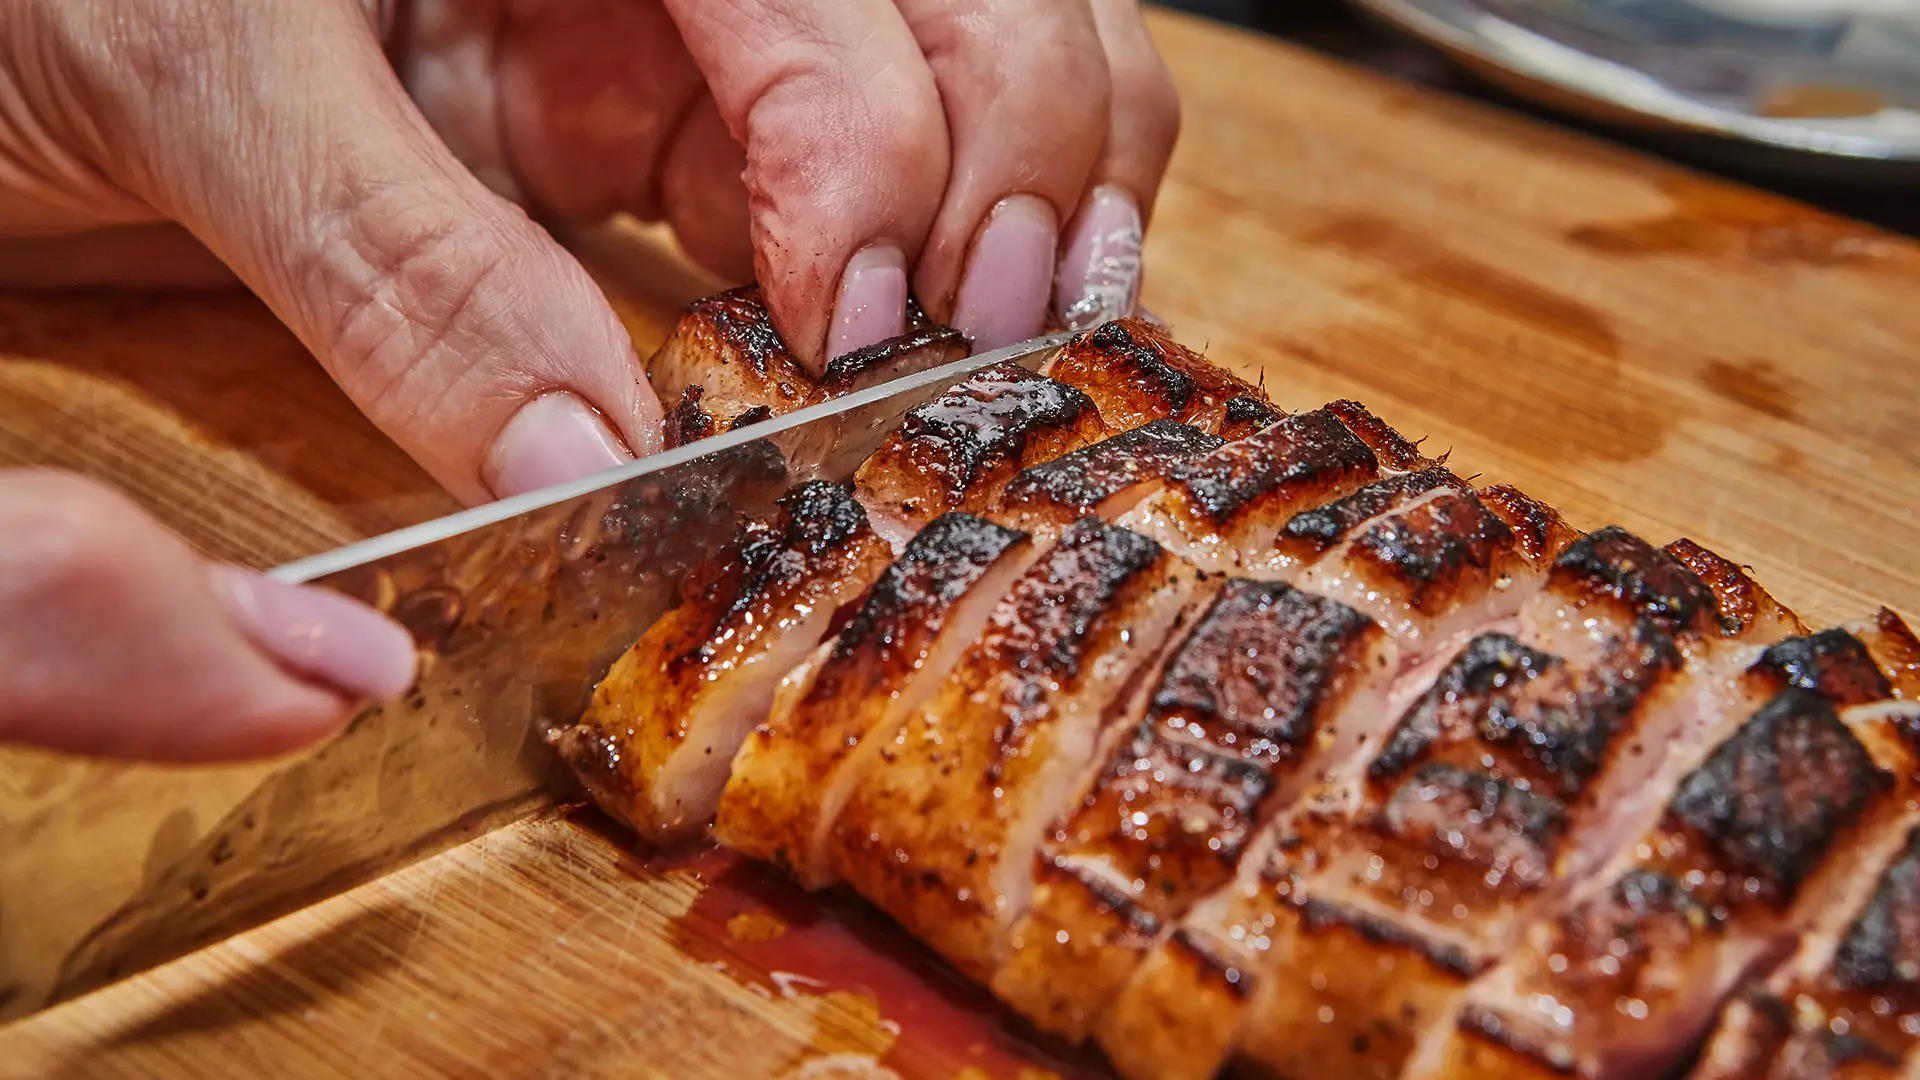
831,519,1196,982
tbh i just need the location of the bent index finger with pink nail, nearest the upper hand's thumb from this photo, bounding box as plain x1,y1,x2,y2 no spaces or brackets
666,0,950,373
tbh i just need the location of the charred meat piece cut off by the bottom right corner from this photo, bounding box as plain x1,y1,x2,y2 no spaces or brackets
1688,807,1920,1080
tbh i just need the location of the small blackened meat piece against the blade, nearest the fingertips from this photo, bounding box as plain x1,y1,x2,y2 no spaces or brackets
854,363,1110,542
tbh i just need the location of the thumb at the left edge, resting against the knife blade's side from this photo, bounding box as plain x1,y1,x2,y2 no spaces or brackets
0,471,417,761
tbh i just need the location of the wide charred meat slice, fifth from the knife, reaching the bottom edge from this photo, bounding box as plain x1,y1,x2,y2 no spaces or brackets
1098,528,1781,1078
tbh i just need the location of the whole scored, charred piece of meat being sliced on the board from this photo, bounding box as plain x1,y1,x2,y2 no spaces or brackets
559,292,1920,1080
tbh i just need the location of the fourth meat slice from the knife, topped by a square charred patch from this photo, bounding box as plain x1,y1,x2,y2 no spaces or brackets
993,578,1394,1042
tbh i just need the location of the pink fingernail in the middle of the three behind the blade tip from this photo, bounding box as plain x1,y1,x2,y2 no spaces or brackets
954,194,1060,352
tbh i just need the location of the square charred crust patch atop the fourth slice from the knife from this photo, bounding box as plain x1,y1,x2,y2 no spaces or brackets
1152,578,1375,757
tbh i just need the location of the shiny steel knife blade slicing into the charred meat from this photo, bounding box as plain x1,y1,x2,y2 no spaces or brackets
0,334,1068,1022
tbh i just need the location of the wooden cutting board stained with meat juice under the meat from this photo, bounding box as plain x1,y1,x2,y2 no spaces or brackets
0,13,1920,1080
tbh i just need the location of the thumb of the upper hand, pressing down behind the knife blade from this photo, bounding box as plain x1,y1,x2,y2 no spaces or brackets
50,0,660,502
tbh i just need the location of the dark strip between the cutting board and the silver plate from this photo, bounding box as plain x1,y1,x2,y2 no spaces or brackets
1156,0,1920,236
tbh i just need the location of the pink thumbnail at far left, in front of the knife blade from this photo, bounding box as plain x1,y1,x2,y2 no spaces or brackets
207,565,419,700
